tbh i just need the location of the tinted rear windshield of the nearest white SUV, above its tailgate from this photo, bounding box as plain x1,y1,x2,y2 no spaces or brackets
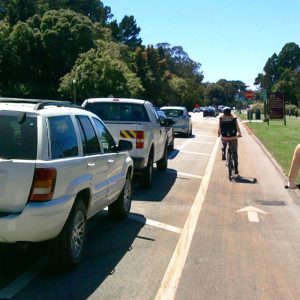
0,111,37,160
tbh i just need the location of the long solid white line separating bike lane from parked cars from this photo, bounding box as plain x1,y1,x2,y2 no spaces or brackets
155,139,219,300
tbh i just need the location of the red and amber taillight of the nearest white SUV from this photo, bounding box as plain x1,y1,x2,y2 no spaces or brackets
29,168,57,202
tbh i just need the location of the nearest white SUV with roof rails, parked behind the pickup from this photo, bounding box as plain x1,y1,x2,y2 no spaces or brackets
0,98,133,269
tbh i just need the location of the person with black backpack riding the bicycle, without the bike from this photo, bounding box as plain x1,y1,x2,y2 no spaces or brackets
218,106,242,174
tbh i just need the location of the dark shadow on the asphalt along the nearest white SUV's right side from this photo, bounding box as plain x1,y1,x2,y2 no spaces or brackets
14,211,146,300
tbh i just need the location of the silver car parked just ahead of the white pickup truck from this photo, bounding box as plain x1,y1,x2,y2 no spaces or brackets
160,106,193,137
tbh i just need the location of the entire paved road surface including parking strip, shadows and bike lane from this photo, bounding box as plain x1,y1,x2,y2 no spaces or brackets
0,114,300,300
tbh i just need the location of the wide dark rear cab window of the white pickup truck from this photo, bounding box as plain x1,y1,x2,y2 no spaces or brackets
85,102,150,122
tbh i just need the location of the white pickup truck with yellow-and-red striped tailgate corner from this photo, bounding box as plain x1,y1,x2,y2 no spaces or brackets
82,98,172,188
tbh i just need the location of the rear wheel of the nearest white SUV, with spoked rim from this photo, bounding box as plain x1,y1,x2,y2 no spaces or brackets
48,196,87,270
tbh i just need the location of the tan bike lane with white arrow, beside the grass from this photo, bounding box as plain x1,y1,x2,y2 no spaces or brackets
175,119,300,300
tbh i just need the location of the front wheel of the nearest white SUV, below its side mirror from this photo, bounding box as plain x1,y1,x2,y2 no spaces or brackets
108,173,132,220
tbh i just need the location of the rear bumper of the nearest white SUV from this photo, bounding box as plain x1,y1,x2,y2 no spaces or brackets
0,196,75,243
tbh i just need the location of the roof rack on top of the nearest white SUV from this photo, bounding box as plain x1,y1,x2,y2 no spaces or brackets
0,97,83,110
